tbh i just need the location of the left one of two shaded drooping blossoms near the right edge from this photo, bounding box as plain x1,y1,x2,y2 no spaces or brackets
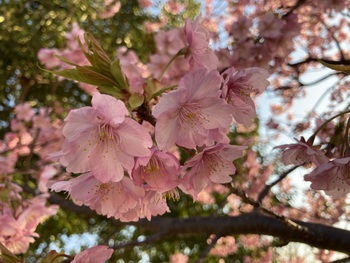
274,138,328,165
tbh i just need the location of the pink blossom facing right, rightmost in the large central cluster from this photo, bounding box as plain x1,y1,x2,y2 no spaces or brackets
223,68,269,127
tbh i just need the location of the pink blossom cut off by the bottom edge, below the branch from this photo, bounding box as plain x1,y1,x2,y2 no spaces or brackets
71,246,113,263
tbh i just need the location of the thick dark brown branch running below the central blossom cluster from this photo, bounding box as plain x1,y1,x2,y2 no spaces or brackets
24,184,350,254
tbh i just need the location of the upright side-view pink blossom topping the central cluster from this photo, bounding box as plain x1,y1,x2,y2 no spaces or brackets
185,16,219,70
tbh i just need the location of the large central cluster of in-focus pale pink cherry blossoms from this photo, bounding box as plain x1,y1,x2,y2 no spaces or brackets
50,17,269,221
